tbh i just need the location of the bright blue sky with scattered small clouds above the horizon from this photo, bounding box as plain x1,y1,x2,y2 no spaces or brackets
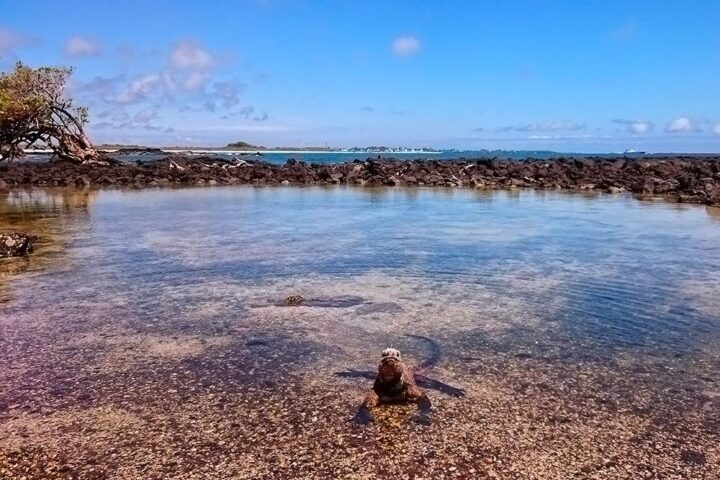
0,0,720,152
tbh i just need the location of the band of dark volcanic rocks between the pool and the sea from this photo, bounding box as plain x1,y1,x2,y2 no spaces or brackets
0,156,720,205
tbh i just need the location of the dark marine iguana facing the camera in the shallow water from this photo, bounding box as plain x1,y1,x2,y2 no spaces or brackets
336,335,465,425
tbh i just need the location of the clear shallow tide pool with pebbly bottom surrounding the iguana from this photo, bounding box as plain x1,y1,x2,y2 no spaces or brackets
0,187,720,479
